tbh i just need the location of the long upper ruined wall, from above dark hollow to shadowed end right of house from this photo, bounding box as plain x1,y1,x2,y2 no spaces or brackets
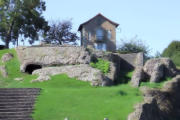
16,45,143,86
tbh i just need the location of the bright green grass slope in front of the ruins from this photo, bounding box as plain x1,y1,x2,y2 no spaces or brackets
0,49,142,120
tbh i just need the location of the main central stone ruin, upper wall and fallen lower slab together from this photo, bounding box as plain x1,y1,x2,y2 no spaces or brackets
16,46,143,86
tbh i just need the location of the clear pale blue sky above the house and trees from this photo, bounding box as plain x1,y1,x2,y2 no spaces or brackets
44,0,180,54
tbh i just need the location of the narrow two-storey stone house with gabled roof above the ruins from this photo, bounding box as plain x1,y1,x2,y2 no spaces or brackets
78,14,119,51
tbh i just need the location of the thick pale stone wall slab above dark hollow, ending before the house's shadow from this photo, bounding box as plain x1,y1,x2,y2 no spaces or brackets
16,46,90,72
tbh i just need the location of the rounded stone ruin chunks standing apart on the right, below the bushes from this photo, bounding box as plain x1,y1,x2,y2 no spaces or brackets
131,58,180,87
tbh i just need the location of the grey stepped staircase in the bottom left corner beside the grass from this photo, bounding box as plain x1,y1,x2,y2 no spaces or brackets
0,88,40,120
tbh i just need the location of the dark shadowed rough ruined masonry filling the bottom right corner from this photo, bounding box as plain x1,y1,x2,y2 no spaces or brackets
128,75,180,120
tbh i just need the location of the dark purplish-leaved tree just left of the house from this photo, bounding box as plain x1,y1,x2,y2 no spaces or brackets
44,21,79,45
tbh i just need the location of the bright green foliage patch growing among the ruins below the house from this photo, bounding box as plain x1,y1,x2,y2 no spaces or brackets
90,58,110,74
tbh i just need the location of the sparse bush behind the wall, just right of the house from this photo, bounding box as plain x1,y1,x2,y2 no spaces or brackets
118,36,150,58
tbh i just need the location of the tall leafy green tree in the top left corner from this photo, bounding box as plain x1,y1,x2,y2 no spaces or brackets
0,0,49,48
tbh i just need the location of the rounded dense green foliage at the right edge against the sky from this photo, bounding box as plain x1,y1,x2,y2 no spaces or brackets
162,41,180,66
